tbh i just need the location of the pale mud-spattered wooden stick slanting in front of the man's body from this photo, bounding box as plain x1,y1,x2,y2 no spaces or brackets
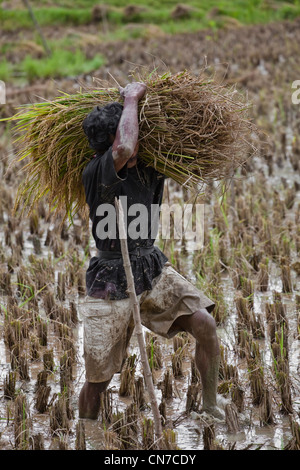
115,198,162,440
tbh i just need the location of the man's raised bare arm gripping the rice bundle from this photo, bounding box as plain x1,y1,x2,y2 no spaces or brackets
112,82,146,172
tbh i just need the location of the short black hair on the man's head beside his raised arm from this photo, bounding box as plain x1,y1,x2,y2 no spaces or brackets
82,103,123,152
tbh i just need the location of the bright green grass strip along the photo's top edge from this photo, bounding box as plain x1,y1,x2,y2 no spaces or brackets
0,0,300,34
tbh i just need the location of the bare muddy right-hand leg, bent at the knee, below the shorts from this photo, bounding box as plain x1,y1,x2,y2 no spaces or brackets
175,309,223,418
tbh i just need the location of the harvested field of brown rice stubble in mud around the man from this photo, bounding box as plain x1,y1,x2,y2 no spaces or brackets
0,21,300,449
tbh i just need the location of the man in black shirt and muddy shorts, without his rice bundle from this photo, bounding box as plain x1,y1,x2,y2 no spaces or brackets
79,82,224,419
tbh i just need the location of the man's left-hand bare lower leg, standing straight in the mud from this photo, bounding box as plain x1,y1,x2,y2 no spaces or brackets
79,380,110,419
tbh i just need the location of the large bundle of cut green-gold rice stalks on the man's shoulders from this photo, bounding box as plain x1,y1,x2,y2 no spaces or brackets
11,72,252,218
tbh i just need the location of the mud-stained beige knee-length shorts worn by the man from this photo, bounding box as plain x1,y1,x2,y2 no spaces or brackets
80,263,215,383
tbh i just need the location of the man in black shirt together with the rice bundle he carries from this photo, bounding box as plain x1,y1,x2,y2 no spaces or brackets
5,70,256,418
